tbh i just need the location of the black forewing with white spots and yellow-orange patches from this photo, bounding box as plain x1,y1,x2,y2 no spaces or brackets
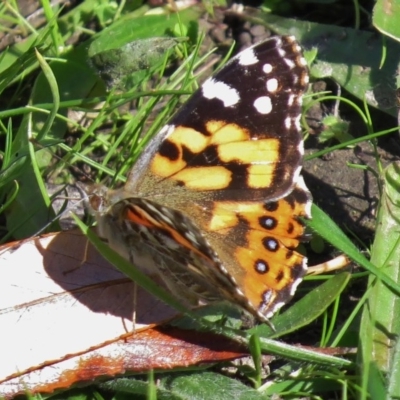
128,37,308,201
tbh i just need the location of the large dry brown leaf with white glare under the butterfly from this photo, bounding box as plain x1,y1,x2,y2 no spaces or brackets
0,231,244,398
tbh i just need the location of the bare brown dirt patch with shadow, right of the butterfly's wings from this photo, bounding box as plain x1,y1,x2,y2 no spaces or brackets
303,142,379,240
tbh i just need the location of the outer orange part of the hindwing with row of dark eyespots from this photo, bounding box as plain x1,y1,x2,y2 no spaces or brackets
235,179,311,318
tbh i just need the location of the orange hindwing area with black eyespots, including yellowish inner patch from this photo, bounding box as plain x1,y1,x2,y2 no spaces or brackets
206,179,311,319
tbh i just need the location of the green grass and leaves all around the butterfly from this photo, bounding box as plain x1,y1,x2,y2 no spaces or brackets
0,1,400,399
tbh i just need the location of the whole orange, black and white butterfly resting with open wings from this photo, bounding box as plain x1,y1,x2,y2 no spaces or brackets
88,36,311,321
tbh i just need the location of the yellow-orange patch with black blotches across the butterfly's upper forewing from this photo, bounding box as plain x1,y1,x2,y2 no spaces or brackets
151,121,280,191
